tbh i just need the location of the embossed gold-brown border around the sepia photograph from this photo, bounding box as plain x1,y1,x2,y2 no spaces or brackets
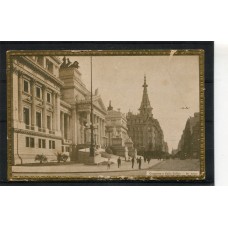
6,49,206,181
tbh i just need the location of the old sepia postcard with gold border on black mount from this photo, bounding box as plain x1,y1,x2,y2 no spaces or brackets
7,49,205,181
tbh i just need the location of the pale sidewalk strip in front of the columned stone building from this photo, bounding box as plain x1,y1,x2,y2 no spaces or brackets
12,159,161,173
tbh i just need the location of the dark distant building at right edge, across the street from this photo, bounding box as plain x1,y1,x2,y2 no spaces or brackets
178,112,200,158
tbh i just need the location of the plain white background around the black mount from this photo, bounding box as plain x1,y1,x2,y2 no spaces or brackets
0,0,228,228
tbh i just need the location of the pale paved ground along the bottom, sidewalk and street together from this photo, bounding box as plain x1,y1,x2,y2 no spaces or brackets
13,159,199,177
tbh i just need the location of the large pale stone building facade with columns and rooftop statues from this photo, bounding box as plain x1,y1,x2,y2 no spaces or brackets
11,56,106,164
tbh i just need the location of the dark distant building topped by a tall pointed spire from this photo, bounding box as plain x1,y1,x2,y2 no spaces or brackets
127,77,168,154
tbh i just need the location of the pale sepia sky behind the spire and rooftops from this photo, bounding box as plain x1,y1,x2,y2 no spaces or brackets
60,56,199,152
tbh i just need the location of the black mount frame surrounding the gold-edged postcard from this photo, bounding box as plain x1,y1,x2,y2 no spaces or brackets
0,42,214,185
